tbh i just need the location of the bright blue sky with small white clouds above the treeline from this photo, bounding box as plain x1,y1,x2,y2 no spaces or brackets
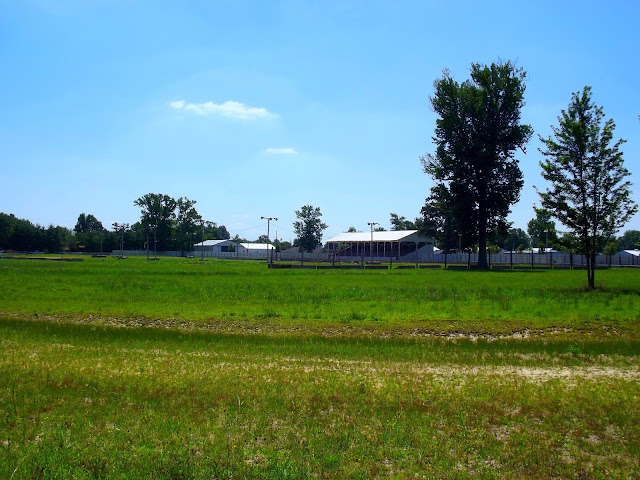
0,0,640,240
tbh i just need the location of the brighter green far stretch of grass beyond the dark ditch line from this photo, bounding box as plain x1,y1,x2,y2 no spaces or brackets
0,257,640,337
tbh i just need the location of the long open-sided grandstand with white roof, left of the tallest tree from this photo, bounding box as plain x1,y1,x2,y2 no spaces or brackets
325,230,435,259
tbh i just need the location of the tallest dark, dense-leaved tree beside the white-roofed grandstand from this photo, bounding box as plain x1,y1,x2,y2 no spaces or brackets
421,62,533,268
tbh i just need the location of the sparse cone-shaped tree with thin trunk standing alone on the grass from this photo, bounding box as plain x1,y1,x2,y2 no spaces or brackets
539,86,638,289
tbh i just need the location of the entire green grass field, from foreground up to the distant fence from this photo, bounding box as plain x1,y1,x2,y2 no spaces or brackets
0,258,640,479
